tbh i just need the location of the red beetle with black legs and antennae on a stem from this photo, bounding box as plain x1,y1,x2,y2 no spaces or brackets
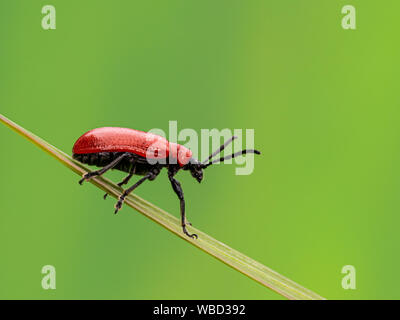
72,127,260,238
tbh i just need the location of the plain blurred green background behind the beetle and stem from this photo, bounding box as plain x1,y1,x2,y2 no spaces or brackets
0,0,400,299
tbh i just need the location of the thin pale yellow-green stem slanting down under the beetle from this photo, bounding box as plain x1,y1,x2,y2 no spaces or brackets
0,114,324,300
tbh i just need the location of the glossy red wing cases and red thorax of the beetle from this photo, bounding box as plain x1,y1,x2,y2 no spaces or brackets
72,127,192,166
